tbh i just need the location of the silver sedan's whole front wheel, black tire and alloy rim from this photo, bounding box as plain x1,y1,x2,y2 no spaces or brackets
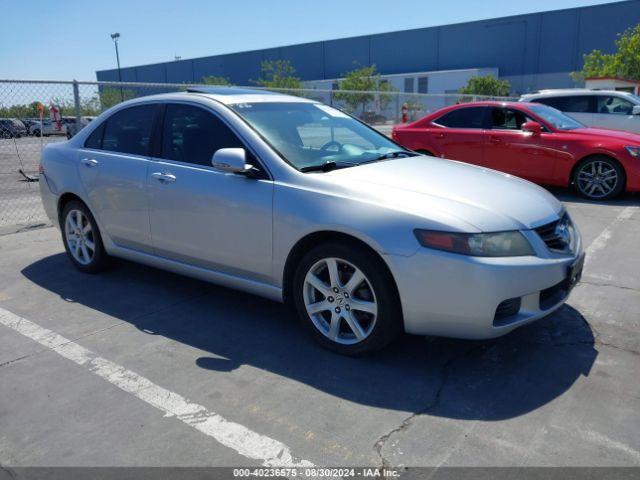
293,244,402,355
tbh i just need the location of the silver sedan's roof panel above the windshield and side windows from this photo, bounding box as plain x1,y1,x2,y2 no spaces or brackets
120,87,317,105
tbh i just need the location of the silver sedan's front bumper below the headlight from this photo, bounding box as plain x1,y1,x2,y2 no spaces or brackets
387,240,584,339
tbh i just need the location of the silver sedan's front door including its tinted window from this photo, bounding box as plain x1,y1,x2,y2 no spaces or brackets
147,103,273,281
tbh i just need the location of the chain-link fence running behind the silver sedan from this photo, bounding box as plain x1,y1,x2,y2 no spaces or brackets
0,80,516,231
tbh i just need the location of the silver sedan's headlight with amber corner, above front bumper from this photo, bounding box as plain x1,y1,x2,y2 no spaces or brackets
414,230,535,257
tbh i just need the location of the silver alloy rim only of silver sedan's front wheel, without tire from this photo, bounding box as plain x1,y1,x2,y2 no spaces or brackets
303,258,378,345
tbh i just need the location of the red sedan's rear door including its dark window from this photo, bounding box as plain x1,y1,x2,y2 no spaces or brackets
429,107,488,165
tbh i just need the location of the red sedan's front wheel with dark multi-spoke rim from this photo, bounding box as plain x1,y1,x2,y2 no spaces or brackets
573,156,625,200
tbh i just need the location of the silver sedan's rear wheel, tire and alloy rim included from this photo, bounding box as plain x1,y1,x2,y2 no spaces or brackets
61,201,108,273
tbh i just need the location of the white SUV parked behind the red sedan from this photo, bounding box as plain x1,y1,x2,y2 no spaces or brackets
520,89,640,133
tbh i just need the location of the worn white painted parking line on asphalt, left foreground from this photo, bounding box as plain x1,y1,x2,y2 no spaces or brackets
0,308,313,467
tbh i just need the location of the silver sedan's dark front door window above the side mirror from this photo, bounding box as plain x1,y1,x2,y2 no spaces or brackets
161,104,244,166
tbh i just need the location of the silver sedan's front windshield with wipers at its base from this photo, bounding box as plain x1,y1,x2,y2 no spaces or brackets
231,102,416,172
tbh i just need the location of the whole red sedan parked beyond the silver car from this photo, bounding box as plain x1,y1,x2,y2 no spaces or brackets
392,102,640,199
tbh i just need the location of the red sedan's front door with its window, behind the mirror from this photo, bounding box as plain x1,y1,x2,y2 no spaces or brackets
484,107,558,183
